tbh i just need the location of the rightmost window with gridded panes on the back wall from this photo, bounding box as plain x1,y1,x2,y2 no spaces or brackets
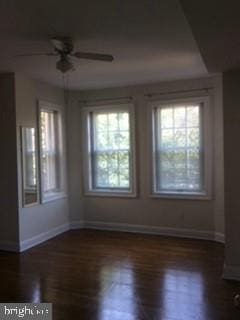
153,98,210,197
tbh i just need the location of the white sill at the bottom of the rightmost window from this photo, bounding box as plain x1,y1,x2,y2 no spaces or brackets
151,192,211,200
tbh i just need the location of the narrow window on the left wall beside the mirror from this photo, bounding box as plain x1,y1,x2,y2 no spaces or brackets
39,103,64,202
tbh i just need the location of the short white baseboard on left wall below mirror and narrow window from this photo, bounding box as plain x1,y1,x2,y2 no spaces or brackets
19,223,69,252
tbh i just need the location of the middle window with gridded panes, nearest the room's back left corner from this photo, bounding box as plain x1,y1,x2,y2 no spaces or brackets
84,105,135,195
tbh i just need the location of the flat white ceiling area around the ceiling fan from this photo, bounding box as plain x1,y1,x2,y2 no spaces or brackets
0,0,207,89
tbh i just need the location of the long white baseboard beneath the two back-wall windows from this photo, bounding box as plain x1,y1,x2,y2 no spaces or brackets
84,221,216,240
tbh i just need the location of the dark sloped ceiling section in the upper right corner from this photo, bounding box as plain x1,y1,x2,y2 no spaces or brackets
180,0,240,72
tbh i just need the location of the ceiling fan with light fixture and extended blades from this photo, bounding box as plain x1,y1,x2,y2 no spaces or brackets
18,37,114,73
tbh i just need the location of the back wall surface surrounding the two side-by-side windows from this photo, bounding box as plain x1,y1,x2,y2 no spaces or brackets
67,76,224,240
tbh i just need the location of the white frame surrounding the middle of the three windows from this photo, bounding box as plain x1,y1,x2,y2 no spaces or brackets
82,103,136,197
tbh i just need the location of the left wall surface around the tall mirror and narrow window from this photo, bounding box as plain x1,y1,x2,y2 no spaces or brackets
15,74,69,249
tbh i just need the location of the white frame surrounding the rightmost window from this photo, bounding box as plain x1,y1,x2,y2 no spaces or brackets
148,96,212,200
